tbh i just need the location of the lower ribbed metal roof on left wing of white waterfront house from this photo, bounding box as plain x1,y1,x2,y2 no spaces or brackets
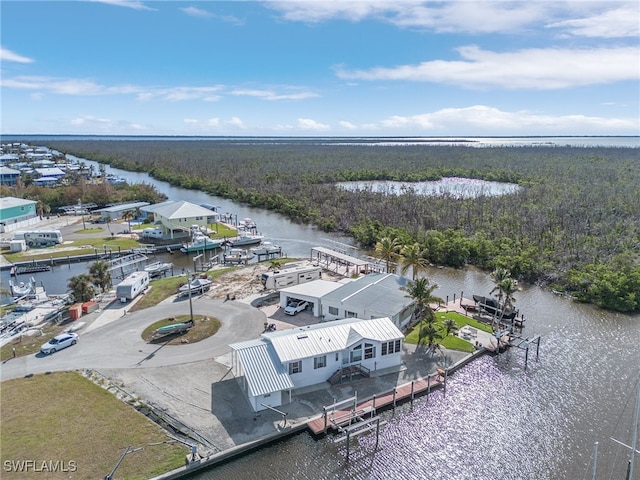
229,338,294,397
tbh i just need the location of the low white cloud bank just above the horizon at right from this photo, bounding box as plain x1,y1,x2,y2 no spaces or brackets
372,105,640,135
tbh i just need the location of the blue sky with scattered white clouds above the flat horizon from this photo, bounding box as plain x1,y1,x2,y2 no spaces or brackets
0,0,640,136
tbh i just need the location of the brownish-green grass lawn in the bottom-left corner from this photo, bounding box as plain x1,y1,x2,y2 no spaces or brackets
0,372,188,480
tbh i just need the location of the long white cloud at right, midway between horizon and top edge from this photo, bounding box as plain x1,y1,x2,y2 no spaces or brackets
336,45,640,90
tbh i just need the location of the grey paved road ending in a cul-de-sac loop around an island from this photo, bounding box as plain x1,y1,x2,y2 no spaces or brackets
0,297,266,380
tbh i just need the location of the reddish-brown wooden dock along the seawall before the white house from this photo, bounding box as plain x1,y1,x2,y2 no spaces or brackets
307,371,446,435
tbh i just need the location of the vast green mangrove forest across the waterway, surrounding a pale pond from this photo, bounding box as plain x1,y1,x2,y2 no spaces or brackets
11,139,640,312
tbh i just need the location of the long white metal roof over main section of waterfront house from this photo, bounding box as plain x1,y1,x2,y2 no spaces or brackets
262,317,404,363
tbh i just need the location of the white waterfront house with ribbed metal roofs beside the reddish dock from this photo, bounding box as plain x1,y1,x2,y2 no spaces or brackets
229,317,404,412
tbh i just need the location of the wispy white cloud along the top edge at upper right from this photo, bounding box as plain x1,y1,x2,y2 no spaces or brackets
263,0,639,37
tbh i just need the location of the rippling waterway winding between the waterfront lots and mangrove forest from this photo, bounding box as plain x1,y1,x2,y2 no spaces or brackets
3,141,640,480
